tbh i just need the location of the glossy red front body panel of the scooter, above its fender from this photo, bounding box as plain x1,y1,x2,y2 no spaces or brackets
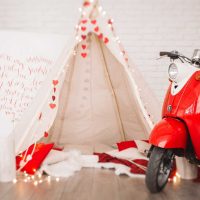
162,71,200,159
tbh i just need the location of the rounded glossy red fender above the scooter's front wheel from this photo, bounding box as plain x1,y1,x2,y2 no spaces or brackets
149,118,187,149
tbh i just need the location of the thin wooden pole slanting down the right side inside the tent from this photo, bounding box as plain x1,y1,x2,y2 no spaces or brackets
95,36,126,141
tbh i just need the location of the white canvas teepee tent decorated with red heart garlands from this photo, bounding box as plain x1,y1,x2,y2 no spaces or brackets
1,1,159,154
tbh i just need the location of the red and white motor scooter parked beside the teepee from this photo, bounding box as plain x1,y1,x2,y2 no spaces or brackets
145,49,200,193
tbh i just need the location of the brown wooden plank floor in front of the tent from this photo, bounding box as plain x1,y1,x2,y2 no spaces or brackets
0,168,200,200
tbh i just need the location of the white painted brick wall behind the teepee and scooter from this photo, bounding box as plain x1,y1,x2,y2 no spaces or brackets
0,0,200,100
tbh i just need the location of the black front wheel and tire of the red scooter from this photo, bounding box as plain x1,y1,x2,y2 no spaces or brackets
145,147,174,193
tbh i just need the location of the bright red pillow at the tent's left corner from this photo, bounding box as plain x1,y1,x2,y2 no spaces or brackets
16,143,54,174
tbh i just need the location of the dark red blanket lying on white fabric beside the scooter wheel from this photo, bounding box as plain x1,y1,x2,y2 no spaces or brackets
95,153,148,174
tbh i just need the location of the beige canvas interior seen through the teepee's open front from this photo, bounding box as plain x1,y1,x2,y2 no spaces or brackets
50,33,148,145
